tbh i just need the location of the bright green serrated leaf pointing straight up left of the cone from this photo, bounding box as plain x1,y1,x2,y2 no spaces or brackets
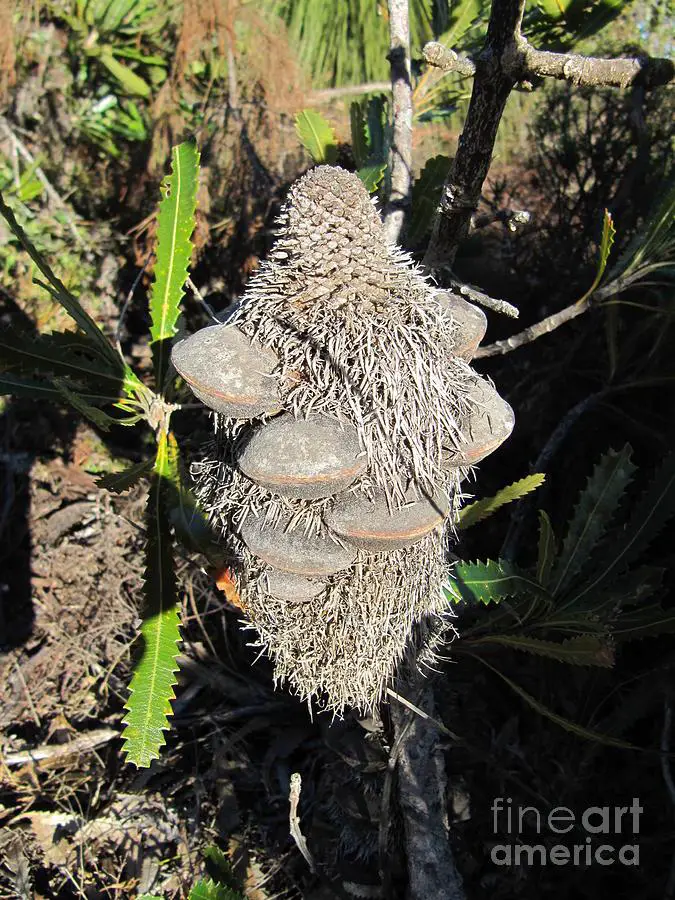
150,141,199,388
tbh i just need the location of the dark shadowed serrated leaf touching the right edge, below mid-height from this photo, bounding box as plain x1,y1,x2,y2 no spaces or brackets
566,453,675,606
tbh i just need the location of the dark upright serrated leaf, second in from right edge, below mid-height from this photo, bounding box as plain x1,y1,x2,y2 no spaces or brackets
551,444,635,596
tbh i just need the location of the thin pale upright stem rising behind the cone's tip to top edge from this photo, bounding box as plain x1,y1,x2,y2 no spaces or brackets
382,0,413,244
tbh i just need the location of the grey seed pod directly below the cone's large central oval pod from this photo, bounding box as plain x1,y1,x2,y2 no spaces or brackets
240,516,356,578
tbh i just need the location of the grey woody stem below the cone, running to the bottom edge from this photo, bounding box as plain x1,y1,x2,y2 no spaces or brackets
391,686,465,900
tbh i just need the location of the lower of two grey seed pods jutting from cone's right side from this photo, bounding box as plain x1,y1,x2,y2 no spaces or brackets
443,378,515,469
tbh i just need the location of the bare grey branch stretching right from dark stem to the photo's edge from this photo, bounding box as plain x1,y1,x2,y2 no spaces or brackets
504,38,675,88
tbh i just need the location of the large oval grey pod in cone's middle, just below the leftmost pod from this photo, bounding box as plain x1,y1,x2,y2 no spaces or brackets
237,415,367,500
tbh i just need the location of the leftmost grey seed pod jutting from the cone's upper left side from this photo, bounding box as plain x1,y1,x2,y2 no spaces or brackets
171,325,282,419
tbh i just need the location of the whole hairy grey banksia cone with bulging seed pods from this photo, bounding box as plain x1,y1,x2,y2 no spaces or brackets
173,166,513,713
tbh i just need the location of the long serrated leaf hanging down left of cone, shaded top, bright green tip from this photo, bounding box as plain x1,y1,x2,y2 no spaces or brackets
122,435,180,768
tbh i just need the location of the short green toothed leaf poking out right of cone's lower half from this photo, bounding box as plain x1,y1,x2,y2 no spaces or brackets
444,559,548,604
